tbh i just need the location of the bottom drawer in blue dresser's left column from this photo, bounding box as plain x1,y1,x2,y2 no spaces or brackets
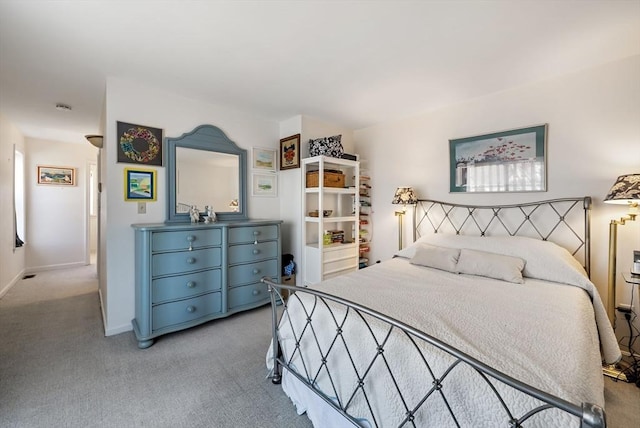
152,292,222,330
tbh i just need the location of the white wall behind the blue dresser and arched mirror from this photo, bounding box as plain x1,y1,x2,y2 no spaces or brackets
100,78,280,335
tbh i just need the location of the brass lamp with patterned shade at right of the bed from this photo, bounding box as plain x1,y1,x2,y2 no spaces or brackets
603,174,640,382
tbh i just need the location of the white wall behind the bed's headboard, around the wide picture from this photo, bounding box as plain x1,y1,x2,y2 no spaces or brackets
354,56,640,310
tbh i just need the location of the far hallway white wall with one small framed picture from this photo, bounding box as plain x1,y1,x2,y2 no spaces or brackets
25,138,97,272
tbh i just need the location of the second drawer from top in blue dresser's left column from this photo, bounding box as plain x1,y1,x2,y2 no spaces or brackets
151,248,222,277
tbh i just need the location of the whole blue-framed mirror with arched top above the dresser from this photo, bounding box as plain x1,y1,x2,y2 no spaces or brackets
166,125,248,223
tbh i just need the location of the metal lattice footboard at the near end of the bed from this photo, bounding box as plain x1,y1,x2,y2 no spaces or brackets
262,278,606,428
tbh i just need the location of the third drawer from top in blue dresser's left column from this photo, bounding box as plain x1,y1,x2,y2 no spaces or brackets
151,269,222,304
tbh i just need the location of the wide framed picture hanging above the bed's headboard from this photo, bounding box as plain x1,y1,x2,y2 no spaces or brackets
449,124,547,193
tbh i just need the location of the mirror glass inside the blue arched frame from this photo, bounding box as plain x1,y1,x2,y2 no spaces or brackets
176,147,240,213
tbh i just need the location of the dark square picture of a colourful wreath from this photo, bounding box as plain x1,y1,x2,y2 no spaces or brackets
117,122,162,166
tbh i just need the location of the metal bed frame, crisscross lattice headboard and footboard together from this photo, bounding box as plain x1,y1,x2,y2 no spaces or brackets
262,197,606,428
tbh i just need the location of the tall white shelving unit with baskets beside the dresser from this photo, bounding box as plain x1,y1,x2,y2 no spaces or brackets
301,156,360,285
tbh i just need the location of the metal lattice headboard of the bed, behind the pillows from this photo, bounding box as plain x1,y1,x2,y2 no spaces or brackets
413,196,591,275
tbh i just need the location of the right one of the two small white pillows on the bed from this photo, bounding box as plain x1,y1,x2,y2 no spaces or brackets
457,248,524,284
